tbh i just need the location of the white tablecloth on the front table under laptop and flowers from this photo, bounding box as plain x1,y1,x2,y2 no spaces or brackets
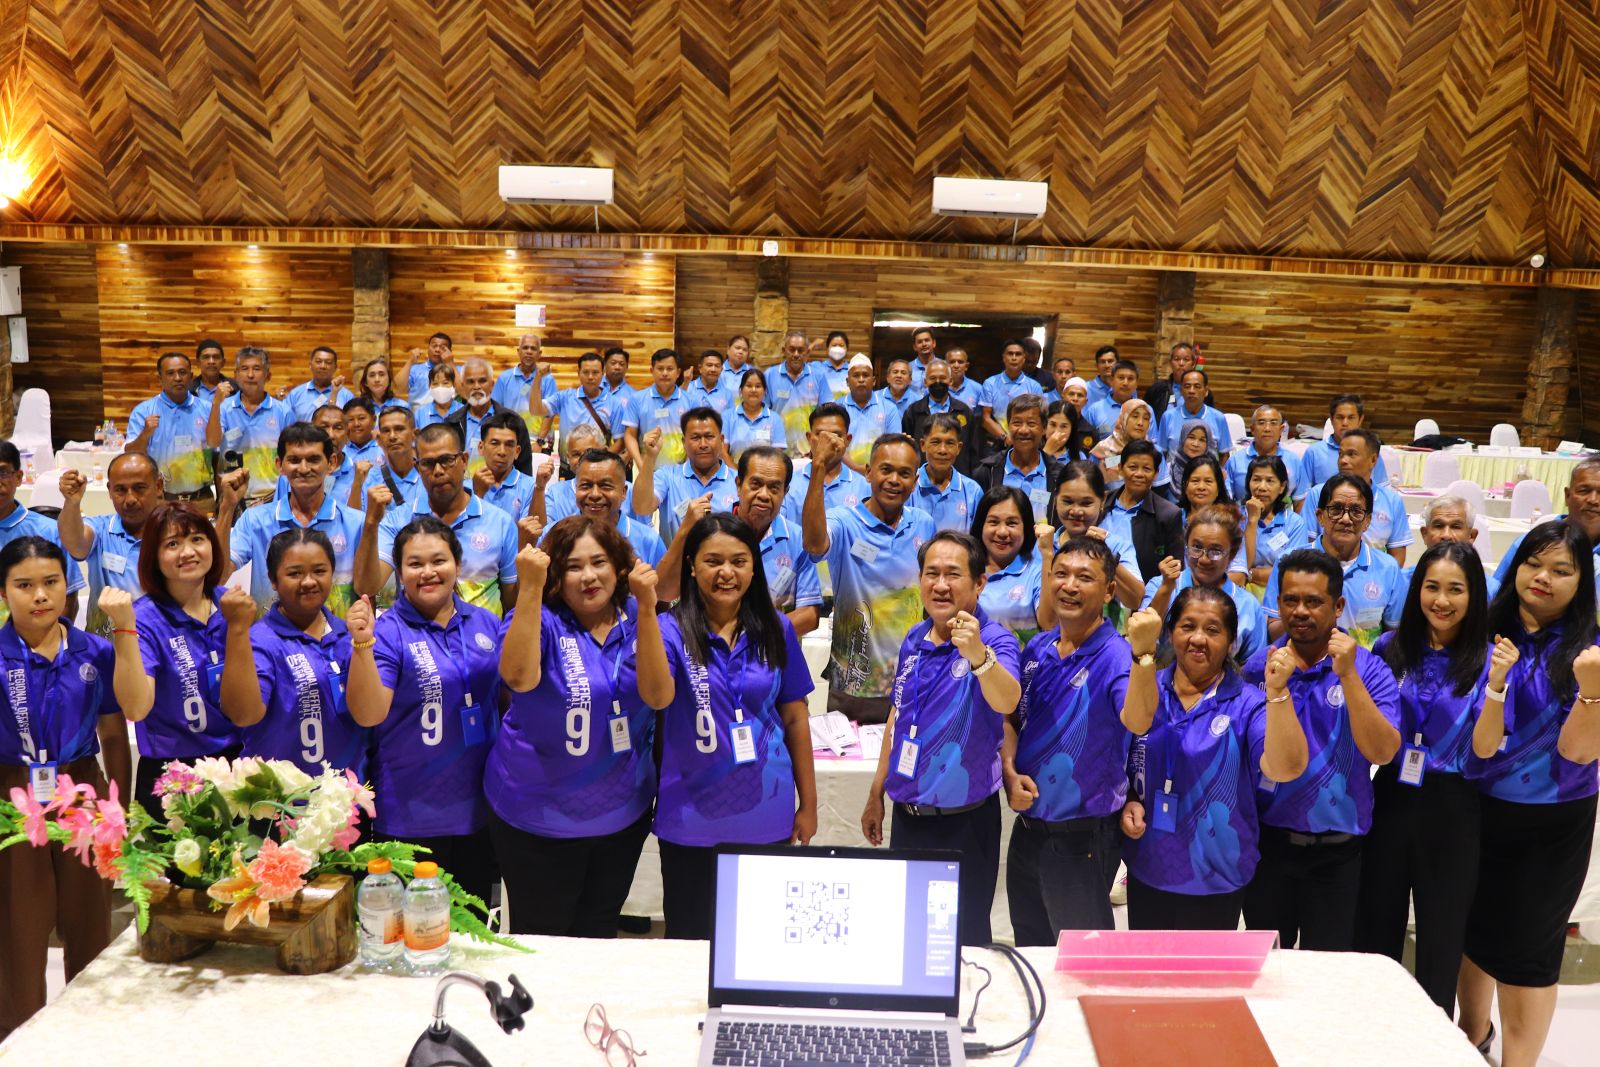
0,931,1483,1067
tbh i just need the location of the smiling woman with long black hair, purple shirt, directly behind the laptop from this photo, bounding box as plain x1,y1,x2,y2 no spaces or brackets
656,514,816,937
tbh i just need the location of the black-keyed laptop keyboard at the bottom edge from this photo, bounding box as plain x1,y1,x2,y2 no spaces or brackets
710,1021,950,1067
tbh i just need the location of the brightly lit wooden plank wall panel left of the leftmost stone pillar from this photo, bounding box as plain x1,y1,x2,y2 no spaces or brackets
96,245,352,422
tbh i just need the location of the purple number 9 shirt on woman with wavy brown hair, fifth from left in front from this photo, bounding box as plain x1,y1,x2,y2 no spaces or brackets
483,598,656,837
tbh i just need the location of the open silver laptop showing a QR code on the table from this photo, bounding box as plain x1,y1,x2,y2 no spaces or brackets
699,846,966,1067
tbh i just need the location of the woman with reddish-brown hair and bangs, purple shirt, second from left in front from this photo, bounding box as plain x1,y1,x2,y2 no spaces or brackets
99,504,238,817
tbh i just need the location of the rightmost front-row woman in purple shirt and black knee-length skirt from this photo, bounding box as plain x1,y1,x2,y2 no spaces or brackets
1456,522,1600,1067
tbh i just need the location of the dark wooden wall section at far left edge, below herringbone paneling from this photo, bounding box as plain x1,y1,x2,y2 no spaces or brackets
0,242,104,442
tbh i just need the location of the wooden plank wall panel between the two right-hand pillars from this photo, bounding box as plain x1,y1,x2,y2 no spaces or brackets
1194,275,1534,443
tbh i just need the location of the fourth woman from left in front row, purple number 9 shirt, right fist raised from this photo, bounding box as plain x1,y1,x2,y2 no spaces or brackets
346,515,501,901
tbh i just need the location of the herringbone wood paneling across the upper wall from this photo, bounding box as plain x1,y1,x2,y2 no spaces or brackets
0,0,1600,266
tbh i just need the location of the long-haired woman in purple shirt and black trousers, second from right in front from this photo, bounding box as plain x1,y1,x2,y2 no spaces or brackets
1356,547,1509,1014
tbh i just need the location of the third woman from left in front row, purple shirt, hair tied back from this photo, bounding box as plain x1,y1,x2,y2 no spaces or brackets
222,526,373,779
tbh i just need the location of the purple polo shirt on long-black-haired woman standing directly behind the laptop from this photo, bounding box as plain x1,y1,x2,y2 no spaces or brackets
656,614,813,848
